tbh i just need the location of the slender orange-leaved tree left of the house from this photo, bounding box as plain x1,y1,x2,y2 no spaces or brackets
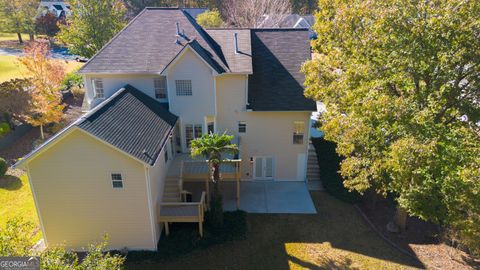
19,42,65,139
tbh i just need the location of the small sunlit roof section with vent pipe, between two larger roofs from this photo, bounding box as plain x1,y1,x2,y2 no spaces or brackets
206,29,252,73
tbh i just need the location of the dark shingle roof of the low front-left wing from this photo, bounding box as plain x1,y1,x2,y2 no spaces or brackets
76,85,177,165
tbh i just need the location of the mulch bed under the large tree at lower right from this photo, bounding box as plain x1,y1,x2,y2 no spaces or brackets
358,195,480,269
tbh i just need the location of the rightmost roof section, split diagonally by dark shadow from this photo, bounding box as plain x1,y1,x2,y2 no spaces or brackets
248,28,316,111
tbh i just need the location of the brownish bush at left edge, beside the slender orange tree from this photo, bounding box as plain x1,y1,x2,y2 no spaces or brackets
0,79,31,127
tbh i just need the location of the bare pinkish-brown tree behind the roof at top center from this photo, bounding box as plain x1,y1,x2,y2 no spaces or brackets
220,0,291,27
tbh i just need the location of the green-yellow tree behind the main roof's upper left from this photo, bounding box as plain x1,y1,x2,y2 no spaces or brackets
57,0,126,58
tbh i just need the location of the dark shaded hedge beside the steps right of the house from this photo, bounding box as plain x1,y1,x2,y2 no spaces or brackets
312,138,361,203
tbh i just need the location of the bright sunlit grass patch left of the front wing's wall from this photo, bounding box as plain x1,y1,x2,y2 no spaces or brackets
0,174,41,240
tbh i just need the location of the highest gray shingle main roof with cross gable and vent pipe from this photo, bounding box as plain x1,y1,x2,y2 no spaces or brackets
79,8,228,73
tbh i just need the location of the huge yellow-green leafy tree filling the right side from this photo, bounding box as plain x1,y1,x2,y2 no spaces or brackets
303,0,480,253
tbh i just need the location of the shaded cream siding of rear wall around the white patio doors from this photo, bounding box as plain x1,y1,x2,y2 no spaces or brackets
217,75,311,181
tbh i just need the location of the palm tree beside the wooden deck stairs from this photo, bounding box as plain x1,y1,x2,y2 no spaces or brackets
191,133,238,229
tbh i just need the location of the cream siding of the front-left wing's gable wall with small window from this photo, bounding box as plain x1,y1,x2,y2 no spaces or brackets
28,130,156,249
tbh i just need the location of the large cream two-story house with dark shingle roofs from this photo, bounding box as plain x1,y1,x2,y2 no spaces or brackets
16,8,316,250
